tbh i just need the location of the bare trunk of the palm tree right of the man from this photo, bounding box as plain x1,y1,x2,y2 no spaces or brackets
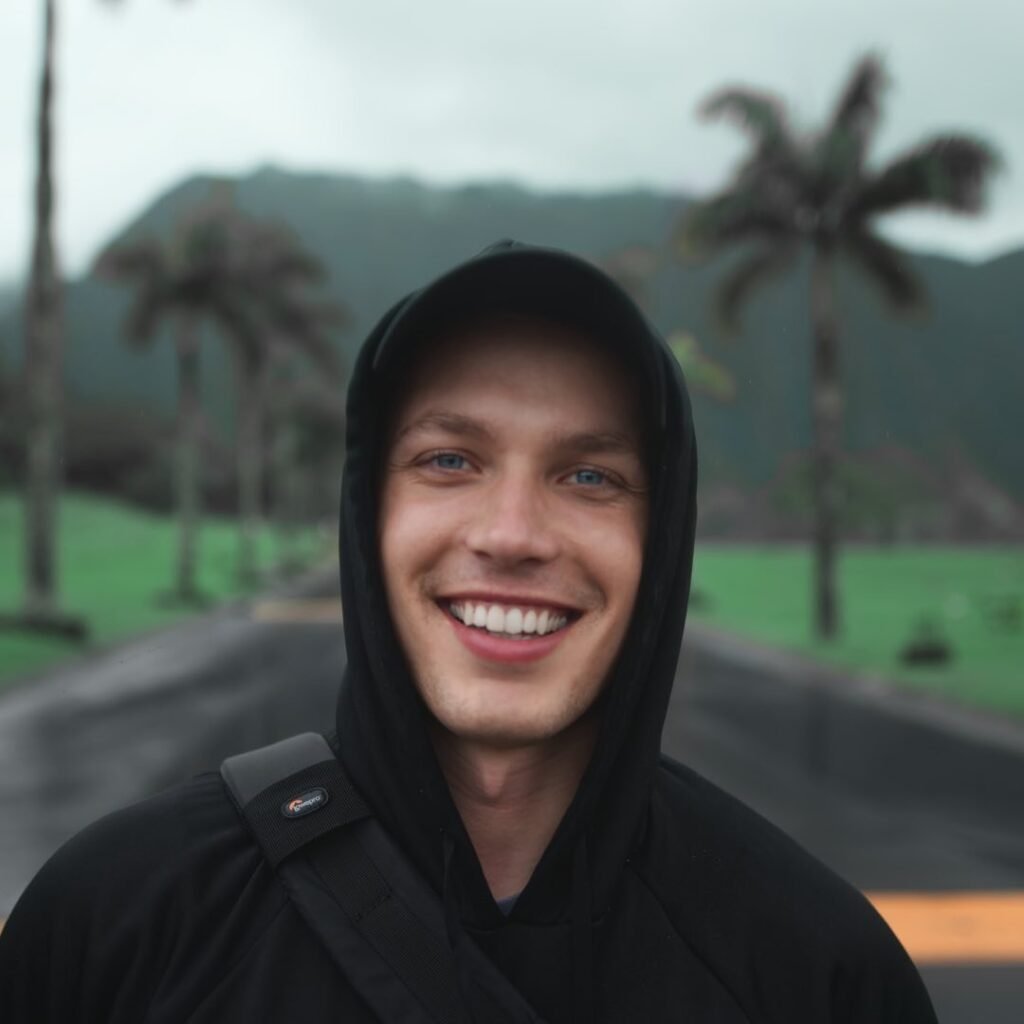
811,245,843,640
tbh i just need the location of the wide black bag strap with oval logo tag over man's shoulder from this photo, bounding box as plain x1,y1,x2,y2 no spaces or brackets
220,733,468,1024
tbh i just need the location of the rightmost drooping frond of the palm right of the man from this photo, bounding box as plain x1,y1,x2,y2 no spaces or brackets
850,135,1001,220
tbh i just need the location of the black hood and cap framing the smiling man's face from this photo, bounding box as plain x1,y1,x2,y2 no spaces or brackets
337,243,696,928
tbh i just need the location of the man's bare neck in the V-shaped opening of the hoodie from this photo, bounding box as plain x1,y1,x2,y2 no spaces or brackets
433,718,597,900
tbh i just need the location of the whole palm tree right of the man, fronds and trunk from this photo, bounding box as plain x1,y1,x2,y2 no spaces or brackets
675,55,998,639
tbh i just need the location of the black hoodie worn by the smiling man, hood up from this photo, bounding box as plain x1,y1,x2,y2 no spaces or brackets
0,244,935,1024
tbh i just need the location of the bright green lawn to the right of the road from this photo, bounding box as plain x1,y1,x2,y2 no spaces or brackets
692,544,1024,717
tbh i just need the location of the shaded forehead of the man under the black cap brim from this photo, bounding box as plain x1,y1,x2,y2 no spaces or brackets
389,315,643,439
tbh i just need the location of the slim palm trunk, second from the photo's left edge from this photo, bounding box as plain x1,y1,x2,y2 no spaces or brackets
174,312,202,602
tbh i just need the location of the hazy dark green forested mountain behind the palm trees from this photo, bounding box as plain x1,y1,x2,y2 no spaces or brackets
0,168,1024,512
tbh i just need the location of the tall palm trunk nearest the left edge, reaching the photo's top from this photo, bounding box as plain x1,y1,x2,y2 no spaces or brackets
25,0,61,622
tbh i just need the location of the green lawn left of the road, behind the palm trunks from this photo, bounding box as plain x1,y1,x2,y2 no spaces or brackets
0,492,328,687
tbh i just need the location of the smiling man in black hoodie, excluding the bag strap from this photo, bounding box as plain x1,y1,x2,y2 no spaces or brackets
0,243,934,1024
